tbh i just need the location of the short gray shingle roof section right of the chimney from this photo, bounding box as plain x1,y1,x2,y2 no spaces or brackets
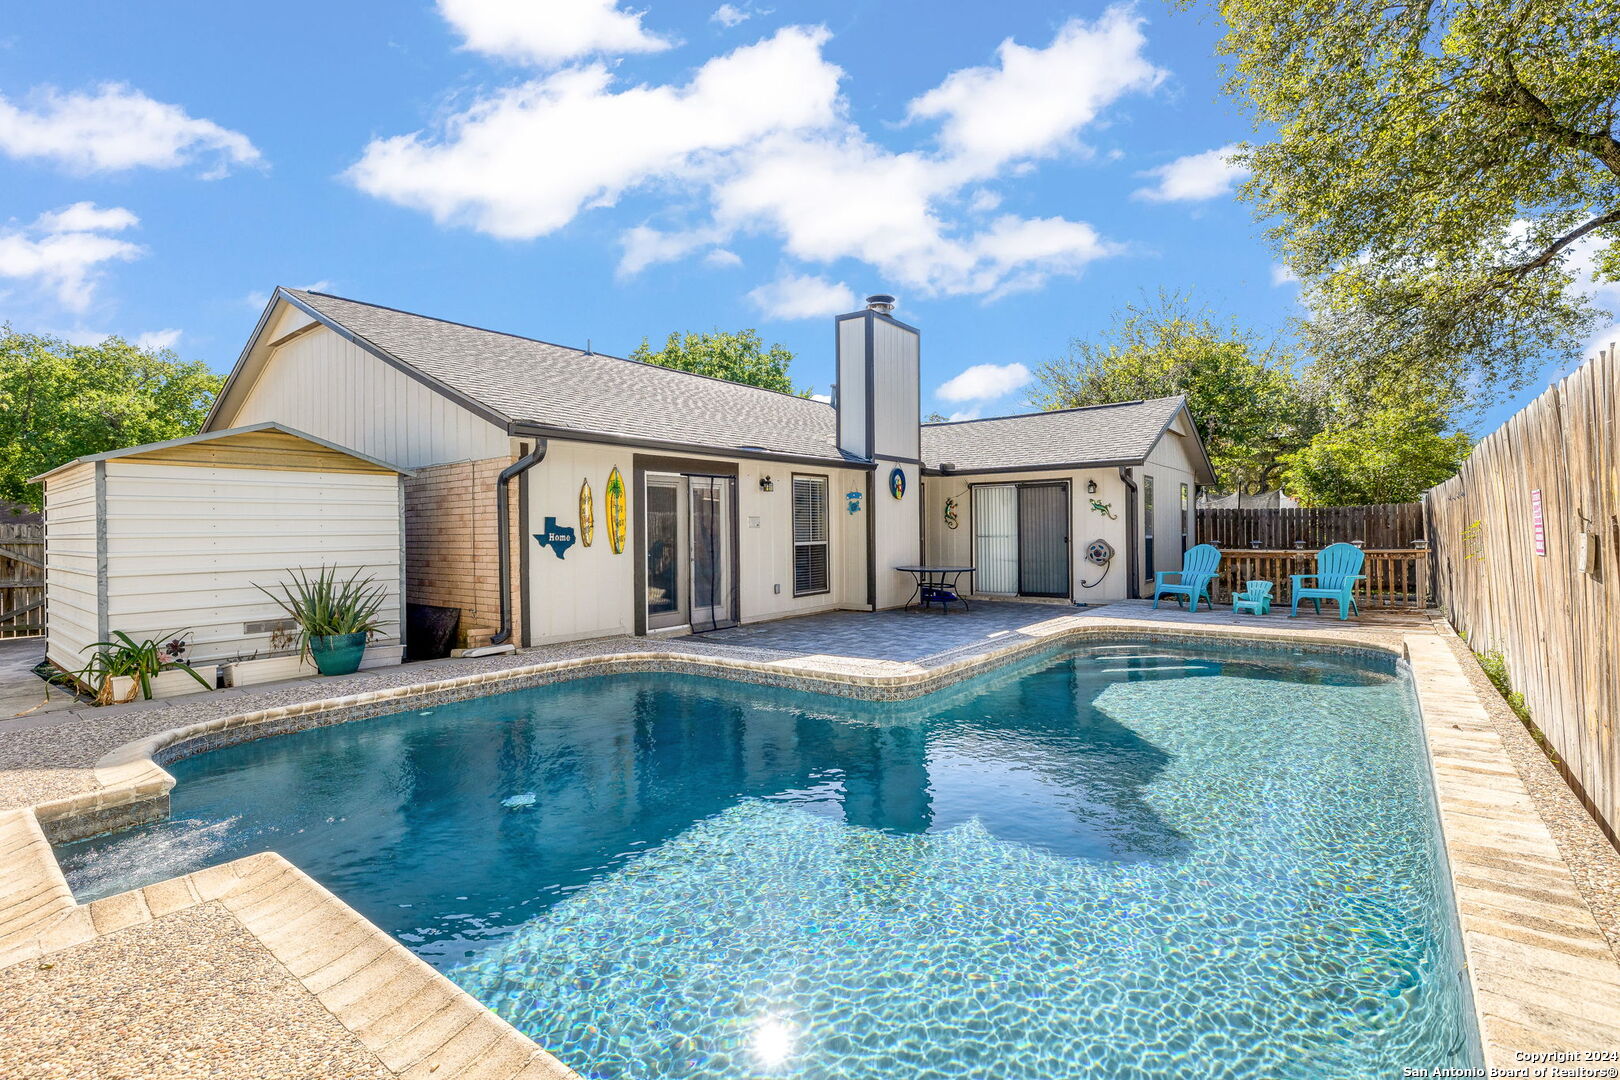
922,397,1186,473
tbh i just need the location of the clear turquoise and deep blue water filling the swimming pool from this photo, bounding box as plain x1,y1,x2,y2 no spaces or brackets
58,641,1479,1080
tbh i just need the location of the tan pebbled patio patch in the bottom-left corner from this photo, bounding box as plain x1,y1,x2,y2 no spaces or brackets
0,904,394,1080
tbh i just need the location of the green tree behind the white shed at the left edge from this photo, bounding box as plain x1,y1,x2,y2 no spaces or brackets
0,324,224,507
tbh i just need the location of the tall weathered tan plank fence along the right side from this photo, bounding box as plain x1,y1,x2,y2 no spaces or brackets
1424,350,1620,834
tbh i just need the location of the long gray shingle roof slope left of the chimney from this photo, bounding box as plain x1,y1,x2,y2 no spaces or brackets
285,288,846,460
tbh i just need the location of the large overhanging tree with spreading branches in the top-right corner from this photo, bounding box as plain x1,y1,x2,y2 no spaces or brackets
1211,0,1620,403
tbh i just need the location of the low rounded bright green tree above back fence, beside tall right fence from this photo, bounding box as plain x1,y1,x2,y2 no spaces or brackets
1283,406,1473,507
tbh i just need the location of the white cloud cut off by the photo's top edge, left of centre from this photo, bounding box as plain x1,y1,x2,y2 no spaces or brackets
439,0,672,66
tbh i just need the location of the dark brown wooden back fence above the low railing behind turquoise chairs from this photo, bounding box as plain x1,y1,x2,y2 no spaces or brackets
1197,502,1427,551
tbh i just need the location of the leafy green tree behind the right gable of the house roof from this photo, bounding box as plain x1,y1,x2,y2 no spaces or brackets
1030,293,1324,494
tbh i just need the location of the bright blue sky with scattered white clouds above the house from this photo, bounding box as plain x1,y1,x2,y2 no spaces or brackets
0,0,1594,434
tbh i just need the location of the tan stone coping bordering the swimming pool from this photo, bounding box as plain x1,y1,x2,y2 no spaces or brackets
0,615,1620,1080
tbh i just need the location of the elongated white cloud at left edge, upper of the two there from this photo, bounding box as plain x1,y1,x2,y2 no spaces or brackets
0,83,262,178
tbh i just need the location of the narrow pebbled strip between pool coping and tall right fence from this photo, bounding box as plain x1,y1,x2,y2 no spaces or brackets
1435,620,1620,959
